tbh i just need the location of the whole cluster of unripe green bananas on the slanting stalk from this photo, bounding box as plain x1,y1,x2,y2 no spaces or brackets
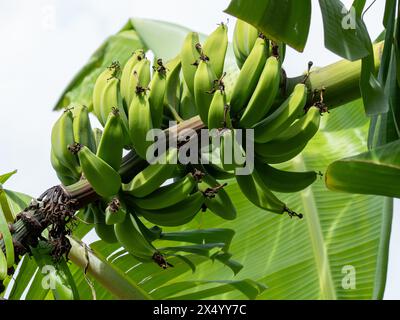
51,20,320,267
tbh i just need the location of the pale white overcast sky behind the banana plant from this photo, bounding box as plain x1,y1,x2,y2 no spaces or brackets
0,0,400,299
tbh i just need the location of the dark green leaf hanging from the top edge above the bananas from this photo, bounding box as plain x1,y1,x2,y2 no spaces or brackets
225,0,311,51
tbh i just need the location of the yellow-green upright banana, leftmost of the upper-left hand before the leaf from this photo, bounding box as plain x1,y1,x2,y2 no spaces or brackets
92,62,120,127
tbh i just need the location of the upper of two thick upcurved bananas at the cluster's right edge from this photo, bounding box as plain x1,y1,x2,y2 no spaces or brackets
254,83,307,143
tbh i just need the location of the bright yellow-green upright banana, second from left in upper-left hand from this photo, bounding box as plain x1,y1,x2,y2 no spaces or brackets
120,49,146,107
